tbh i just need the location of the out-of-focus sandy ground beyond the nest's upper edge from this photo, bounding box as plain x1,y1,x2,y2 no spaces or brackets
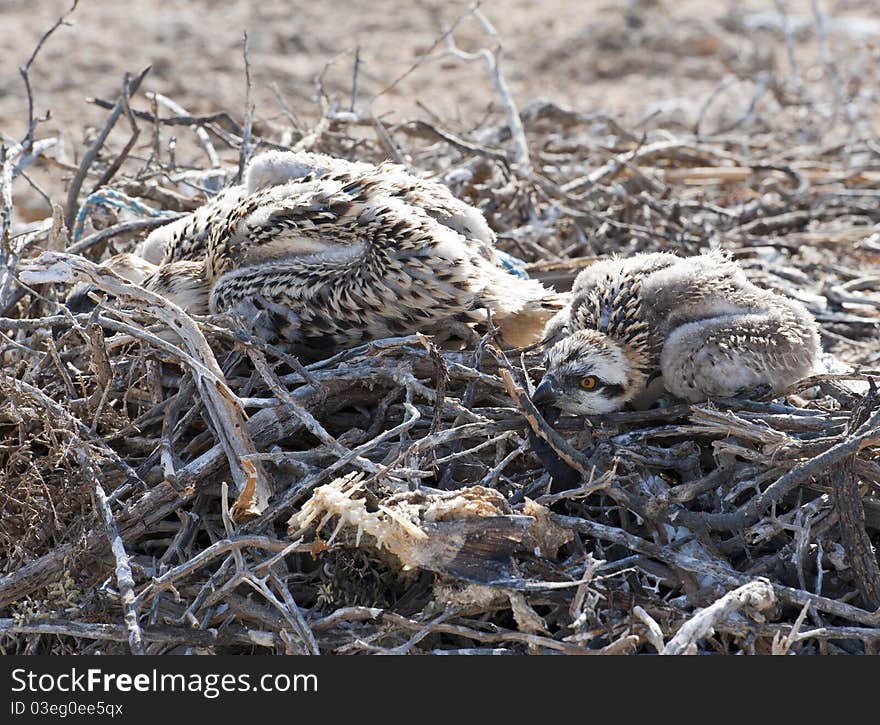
0,0,880,138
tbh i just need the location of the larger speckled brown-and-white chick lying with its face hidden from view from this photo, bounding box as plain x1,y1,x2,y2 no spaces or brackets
70,152,561,353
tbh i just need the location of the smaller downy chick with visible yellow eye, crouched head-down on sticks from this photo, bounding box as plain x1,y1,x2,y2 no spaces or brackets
533,252,819,415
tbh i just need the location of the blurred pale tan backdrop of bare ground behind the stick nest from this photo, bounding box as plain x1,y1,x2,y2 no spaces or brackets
0,0,880,235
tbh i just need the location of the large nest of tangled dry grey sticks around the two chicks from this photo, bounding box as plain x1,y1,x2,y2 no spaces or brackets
0,2,880,654
